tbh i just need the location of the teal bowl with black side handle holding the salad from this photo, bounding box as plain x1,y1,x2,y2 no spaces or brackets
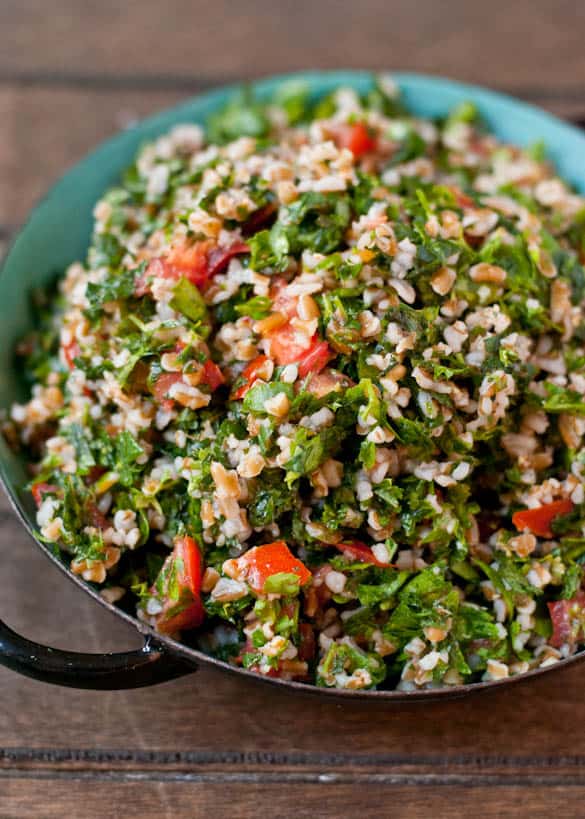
0,71,585,701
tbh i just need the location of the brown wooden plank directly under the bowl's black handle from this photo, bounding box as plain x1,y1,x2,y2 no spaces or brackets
0,480,585,768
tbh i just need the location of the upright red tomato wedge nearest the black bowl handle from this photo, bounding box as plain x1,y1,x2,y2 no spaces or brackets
152,535,205,634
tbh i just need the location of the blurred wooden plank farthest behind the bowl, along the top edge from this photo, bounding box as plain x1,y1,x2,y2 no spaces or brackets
0,0,585,98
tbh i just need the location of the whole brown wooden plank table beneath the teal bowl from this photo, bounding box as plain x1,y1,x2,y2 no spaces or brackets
0,0,585,819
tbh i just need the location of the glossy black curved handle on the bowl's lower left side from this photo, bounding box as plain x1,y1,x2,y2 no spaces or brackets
0,620,197,690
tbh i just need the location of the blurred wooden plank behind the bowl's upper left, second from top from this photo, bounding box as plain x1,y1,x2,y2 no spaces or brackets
0,84,585,234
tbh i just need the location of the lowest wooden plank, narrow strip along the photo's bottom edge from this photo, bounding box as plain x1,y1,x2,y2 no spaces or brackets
0,779,585,819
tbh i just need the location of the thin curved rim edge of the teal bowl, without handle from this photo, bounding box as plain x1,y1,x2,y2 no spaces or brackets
0,69,585,703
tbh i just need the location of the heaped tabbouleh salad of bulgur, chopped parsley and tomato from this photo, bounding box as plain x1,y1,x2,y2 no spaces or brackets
4,77,585,690
